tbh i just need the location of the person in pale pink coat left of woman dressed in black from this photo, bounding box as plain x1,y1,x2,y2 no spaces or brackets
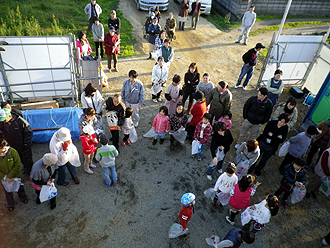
164,74,183,115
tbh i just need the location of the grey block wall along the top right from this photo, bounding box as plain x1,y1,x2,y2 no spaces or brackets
212,0,330,19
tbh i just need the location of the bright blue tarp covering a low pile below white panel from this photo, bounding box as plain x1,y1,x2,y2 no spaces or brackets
22,107,83,143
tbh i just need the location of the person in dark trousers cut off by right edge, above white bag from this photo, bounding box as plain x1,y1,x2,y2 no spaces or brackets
306,148,330,199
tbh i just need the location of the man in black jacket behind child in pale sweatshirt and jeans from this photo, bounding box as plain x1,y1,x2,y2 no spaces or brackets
105,94,126,150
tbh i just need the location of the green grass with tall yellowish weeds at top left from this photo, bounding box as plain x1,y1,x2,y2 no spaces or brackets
0,0,136,56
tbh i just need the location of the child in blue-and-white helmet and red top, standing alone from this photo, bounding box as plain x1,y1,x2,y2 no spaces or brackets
179,193,196,231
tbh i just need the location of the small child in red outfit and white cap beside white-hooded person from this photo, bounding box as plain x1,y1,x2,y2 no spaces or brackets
80,125,98,175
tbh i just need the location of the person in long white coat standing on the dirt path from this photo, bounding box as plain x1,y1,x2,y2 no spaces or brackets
150,57,168,103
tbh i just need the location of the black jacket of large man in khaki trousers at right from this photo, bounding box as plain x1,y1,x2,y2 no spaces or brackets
243,96,273,124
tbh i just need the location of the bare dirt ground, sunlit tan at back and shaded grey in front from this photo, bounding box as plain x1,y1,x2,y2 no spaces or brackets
0,0,330,248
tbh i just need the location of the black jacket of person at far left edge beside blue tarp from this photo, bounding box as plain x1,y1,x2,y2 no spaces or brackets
0,112,33,151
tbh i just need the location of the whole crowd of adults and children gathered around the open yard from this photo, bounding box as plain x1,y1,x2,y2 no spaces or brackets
0,0,330,247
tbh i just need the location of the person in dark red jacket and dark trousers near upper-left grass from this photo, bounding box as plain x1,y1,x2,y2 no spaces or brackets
104,27,120,72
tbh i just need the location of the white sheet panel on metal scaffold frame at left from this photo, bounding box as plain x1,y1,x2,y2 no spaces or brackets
0,36,72,99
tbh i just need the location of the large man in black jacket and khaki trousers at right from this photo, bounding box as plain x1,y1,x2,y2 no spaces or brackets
235,87,273,149
